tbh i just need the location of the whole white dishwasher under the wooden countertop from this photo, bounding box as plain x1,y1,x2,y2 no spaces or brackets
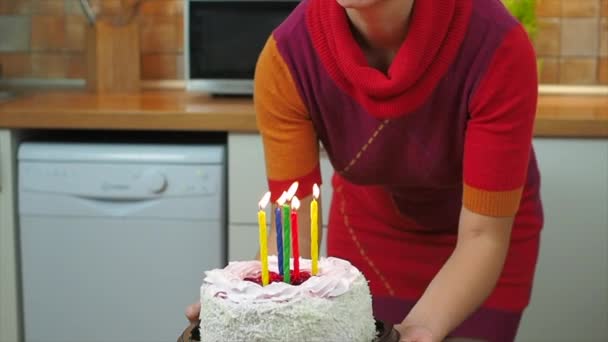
18,142,226,342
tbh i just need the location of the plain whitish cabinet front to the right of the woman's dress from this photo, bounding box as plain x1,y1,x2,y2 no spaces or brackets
518,139,608,342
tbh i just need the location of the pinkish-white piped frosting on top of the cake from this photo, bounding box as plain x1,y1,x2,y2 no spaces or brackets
204,256,360,303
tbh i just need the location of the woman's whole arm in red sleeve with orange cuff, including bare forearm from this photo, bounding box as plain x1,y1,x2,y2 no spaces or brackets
400,25,538,341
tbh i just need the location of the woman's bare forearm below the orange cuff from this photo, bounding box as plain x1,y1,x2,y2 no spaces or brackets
400,207,513,341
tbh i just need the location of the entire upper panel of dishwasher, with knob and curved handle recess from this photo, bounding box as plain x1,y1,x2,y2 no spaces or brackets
18,142,226,220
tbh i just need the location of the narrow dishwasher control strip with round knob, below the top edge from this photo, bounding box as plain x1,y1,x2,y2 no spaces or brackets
19,161,222,198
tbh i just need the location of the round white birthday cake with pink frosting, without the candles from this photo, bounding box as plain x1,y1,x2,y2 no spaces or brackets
200,256,377,342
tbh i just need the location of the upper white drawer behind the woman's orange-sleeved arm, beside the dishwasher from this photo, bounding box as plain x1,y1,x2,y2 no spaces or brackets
228,134,333,225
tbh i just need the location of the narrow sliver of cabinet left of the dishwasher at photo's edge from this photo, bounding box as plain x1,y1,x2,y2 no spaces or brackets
0,129,20,342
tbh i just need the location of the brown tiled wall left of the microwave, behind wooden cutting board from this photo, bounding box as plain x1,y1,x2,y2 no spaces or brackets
0,0,184,79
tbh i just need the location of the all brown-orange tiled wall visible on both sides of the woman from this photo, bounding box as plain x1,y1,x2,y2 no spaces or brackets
0,0,608,84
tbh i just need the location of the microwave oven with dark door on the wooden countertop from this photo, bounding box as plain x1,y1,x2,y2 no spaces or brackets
184,0,299,95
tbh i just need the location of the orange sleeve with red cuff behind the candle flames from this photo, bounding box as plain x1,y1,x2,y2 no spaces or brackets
254,36,321,201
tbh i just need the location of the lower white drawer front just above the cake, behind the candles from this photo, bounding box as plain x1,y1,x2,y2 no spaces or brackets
228,224,327,261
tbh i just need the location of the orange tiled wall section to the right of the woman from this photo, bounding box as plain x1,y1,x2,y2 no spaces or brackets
535,0,608,84
